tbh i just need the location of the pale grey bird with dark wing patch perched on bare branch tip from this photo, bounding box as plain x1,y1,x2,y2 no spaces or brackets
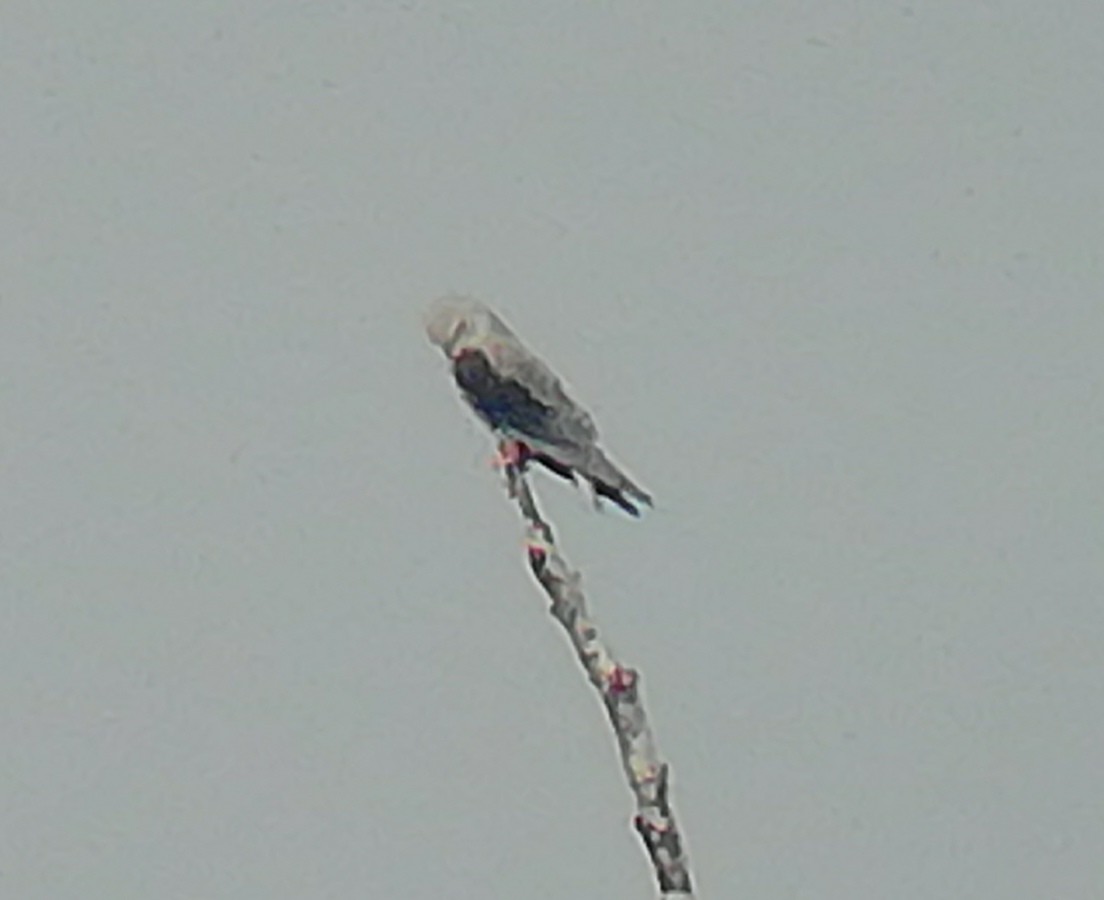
425,296,651,516
